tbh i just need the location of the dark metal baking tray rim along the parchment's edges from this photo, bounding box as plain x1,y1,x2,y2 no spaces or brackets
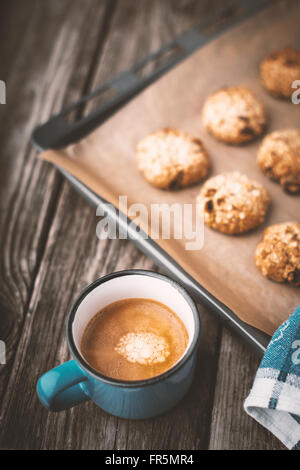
31,0,272,355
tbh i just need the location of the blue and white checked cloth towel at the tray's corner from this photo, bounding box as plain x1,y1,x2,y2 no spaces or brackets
244,306,300,450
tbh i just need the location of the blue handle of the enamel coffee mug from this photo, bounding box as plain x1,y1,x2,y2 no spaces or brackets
37,360,90,411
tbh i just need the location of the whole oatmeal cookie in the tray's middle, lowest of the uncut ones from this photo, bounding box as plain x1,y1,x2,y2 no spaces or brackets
197,172,270,234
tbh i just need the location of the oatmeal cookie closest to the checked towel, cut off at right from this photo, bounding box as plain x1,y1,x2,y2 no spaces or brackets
255,222,300,286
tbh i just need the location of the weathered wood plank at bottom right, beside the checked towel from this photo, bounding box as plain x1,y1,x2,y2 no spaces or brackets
209,329,284,450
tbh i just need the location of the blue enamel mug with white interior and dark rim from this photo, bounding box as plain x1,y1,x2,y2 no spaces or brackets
37,270,200,419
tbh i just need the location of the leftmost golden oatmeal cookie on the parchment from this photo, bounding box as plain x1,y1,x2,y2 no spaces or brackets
137,129,210,189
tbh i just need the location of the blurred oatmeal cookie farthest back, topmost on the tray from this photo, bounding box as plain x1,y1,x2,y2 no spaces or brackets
260,47,300,98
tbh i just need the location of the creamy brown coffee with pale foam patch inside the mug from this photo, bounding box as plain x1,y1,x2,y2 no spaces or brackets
80,298,188,380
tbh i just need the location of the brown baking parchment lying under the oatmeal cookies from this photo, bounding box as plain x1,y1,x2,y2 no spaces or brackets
32,1,300,350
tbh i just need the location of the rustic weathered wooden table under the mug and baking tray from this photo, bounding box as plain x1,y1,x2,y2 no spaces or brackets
0,0,283,450
